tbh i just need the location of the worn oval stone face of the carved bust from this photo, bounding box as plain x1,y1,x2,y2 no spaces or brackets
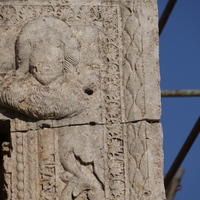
29,43,64,85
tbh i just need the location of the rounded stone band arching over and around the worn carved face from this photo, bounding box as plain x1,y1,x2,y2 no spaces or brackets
15,17,80,73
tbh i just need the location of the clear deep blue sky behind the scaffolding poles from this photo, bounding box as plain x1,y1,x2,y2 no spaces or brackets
157,0,200,200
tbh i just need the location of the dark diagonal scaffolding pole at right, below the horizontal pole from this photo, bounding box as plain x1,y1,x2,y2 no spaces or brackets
164,117,200,190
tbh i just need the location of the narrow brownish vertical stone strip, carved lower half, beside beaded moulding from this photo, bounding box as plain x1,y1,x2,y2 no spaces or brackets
38,129,57,200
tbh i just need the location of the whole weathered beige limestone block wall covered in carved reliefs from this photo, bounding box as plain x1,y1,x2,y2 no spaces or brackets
0,0,165,200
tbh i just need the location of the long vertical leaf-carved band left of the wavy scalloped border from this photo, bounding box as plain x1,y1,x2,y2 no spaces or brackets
101,6,125,200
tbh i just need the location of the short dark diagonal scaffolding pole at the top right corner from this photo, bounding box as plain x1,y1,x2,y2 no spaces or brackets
159,0,177,35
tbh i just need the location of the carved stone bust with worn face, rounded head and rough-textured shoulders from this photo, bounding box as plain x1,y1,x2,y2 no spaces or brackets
0,17,86,119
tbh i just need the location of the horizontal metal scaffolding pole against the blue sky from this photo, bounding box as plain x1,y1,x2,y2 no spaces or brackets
161,90,200,97
